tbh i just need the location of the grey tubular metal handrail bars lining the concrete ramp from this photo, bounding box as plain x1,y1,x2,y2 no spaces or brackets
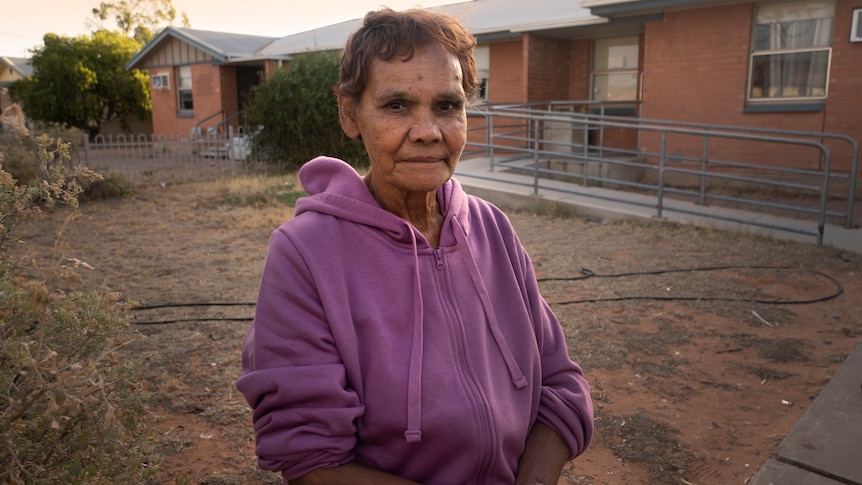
467,103,858,244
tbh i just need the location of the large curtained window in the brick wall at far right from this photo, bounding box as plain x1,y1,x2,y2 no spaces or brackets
748,0,835,101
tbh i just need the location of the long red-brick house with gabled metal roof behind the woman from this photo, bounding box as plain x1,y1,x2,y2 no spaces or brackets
129,0,862,176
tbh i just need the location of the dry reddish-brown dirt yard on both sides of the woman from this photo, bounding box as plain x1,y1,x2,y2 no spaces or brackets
10,179,862,484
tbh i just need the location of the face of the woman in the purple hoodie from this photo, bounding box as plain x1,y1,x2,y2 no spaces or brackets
338,46,467,197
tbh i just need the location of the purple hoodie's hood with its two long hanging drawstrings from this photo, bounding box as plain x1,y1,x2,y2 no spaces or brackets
296,157,528,443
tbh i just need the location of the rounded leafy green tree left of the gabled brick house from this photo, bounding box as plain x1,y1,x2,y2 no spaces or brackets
16,30,151,134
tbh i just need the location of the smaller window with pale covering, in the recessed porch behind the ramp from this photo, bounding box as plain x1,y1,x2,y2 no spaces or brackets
592,36,640,101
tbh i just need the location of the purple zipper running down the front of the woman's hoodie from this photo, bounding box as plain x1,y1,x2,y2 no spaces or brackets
434,249,493,477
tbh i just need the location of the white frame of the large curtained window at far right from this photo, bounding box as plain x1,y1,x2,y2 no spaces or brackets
745,0,835,104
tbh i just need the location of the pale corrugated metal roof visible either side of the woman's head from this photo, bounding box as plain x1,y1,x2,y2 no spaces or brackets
258,0,607,56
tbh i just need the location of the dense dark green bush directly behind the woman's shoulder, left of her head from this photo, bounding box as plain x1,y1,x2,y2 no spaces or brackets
244,52,368,168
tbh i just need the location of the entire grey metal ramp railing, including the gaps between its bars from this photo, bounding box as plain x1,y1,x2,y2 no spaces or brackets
464,102,859,244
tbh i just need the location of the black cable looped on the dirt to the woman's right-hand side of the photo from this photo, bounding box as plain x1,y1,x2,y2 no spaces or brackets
537,265,844,305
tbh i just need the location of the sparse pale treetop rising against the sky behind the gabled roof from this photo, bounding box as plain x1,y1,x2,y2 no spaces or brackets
93,0,189,45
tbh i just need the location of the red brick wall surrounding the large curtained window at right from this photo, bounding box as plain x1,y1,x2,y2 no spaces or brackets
642,0,862,171
